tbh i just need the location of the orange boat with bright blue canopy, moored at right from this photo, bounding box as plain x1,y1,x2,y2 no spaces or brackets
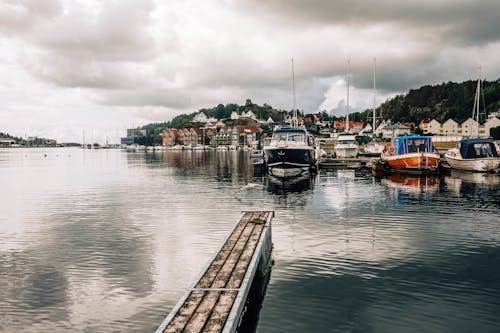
381,135,440,173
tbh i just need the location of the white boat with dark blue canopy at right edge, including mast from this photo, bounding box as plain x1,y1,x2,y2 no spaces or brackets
444,74,500,172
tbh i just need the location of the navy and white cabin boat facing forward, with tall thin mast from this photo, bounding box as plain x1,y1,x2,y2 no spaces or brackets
262,59,320,177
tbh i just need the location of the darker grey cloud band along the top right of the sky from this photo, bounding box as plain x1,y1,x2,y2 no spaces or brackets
239,0,500,45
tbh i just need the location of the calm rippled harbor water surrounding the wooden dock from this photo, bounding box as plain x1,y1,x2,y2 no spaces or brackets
0,148,500,332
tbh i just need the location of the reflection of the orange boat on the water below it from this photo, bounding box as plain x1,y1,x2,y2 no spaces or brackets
381,173,439,203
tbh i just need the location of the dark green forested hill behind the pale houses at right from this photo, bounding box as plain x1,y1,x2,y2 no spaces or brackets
376,79,500,123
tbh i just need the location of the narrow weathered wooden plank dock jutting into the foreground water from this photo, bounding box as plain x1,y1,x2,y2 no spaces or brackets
156,211,274,333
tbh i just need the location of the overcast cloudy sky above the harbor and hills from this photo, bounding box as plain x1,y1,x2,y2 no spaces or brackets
0,0,500,142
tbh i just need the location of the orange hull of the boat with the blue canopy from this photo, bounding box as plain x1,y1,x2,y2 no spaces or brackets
382,153,440,172
